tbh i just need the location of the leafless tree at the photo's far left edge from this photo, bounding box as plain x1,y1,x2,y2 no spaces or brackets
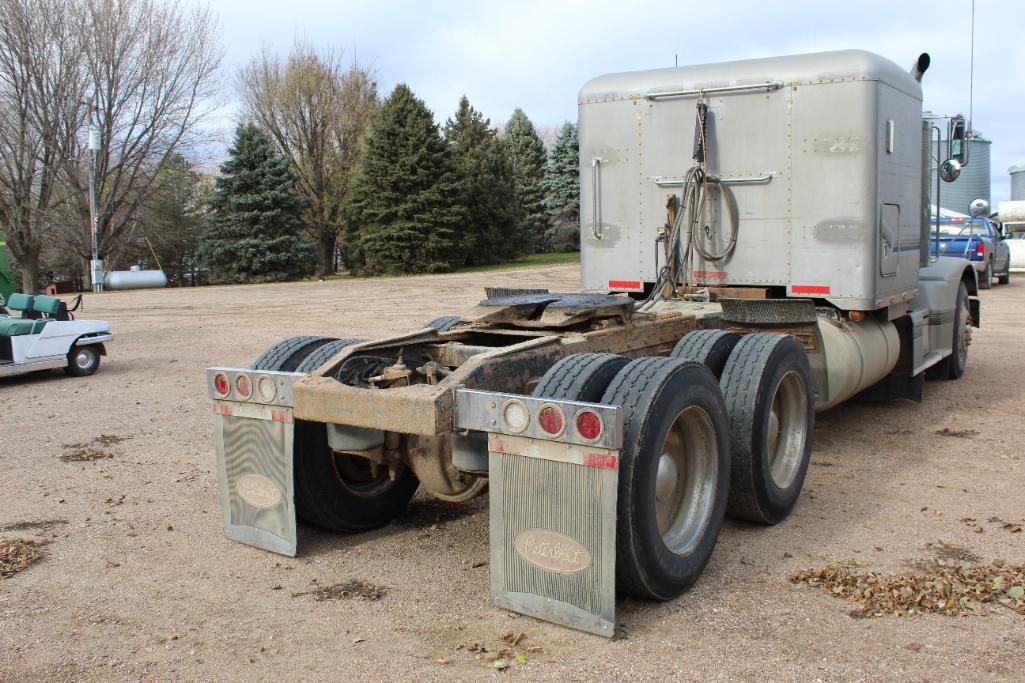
0,0,85,293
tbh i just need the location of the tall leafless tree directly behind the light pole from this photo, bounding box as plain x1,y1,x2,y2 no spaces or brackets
66,0,223,266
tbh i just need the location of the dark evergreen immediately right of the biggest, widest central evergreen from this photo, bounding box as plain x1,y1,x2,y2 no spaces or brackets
445,95,527,265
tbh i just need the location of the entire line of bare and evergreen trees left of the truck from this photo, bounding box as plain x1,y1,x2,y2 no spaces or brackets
0,0,579,291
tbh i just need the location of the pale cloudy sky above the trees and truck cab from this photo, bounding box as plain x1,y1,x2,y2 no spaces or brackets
211,0,1025,201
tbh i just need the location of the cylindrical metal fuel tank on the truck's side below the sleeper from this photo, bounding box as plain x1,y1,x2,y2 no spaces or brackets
815,316,900,410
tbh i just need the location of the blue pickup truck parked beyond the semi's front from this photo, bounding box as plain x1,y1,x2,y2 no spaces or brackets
930,216,1011,289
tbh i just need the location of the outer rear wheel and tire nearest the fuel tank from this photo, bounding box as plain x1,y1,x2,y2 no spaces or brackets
721,332,815,524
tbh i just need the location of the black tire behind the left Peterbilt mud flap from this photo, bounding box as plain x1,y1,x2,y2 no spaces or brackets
294,419,420,533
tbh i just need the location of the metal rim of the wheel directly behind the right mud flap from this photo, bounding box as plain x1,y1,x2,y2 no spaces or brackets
655,406,719,555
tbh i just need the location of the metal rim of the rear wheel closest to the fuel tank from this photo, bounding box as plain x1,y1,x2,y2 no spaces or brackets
766,370,808,488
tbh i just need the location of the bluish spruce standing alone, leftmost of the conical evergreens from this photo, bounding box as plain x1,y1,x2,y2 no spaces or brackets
199,124,317,283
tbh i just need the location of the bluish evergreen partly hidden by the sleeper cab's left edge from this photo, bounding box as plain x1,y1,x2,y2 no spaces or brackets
544,122,580,251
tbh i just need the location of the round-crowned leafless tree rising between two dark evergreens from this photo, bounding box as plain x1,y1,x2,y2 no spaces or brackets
239,42,380,275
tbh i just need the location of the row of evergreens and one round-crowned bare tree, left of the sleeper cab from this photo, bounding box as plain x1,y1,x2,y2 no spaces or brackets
198,77,579,282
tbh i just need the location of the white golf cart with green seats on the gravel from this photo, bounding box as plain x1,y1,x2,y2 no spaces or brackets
0,293,114,377
